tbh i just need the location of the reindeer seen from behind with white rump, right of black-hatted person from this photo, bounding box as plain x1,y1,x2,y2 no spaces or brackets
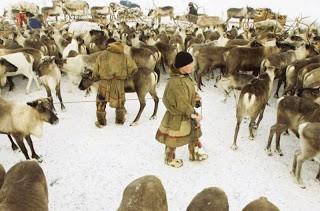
231,68,275,150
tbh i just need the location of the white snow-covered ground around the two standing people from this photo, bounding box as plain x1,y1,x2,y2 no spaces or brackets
0,74,320,211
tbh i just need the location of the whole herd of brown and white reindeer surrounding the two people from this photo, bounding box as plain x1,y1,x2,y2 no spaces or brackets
0,1,320,211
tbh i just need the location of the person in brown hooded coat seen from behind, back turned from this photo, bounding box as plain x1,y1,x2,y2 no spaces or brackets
93,42,138,128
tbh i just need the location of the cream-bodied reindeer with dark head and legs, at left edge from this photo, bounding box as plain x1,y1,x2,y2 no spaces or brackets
0,98,59,159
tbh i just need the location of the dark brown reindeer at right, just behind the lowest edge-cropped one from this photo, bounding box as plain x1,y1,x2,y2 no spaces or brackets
265,96,320,156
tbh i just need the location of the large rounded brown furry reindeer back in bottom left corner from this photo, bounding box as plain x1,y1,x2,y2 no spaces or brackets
0,161,48,211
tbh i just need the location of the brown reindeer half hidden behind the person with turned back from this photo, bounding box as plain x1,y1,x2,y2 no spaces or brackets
79,67,159,126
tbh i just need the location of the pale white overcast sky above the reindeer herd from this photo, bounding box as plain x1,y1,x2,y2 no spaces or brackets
0,0,320,23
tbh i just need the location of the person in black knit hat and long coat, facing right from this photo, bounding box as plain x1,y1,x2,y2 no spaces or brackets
156,51,208,168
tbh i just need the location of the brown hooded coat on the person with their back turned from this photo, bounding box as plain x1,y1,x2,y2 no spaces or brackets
93,42,138,108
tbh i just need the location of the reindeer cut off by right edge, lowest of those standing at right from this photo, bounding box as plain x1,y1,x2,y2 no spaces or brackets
291,122,320,188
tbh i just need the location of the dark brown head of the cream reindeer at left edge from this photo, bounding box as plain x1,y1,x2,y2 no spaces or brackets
27,97,59,125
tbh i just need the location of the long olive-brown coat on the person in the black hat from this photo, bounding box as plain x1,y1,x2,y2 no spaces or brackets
156,73,201,147
